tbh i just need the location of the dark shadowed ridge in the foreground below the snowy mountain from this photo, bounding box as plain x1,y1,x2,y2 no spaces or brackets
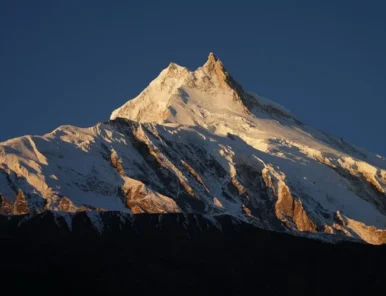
0,212,386,295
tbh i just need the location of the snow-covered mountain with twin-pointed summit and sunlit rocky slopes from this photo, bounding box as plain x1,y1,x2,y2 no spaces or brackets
0,54,386,244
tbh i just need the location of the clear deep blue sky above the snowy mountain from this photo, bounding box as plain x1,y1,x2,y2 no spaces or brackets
0,0,386,156
